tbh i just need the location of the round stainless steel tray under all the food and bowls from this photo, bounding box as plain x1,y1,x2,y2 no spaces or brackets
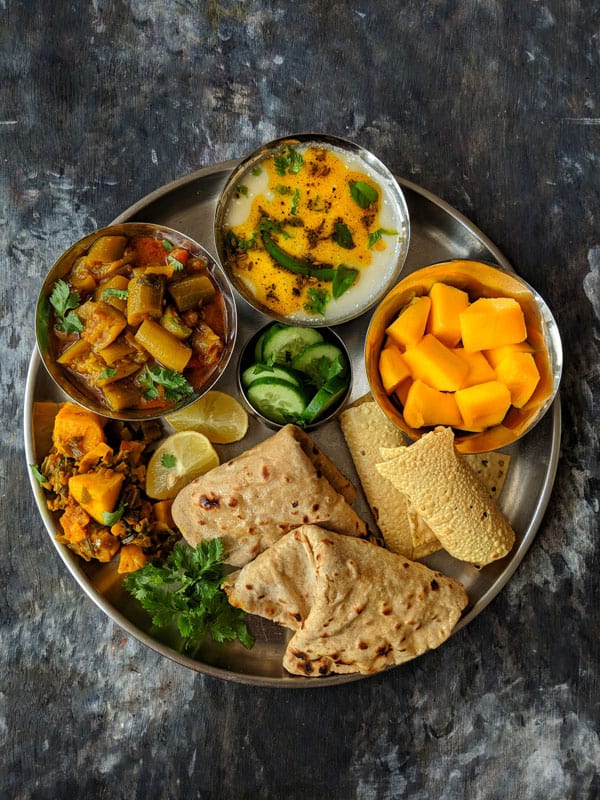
24,161,561,689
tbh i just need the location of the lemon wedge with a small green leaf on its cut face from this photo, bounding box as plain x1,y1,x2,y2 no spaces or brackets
146,431,220,500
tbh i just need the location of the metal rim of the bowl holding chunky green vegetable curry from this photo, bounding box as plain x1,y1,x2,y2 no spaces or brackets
35,222,238,422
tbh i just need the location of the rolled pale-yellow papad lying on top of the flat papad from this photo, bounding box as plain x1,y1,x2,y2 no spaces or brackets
377,427,515,567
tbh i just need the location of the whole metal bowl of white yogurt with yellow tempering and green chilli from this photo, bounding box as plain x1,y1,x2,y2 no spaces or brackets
215,133,410,327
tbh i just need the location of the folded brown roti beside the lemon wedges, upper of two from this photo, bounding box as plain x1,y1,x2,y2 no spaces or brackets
172,425,367,567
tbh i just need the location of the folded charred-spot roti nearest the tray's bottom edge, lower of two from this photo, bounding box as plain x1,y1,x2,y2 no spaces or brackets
224,525,468,676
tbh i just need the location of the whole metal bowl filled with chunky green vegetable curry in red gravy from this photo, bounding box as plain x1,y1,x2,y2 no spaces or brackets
36,222,237,420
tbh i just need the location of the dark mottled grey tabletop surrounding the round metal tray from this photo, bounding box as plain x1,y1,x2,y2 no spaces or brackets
0,0,600,800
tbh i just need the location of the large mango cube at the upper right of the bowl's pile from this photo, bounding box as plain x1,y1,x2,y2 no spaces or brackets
460,297,527,351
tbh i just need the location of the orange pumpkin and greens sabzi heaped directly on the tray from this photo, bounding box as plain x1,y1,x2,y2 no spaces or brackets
33,403,180,573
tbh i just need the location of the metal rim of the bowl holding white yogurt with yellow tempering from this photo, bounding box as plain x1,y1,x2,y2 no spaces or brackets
213,131,411,328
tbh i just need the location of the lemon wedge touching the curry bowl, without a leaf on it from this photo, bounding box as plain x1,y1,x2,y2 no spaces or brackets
166,390,248,444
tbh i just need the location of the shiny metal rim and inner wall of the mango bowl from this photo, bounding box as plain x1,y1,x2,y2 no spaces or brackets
364,258,563,453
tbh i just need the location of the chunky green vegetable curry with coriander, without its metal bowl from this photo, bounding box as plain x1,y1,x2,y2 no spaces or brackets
49,235,227,414
